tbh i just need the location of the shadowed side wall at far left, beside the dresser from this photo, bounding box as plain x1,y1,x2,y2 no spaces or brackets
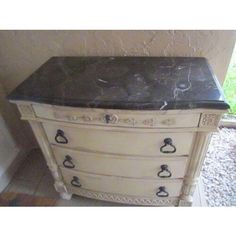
0,83,29,192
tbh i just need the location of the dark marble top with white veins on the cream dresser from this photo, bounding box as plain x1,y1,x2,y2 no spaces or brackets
8,57,229,110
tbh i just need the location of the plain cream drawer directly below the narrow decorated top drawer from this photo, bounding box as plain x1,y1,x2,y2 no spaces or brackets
43,123,194,156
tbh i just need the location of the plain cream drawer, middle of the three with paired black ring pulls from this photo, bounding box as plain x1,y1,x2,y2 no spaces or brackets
52,145,188,179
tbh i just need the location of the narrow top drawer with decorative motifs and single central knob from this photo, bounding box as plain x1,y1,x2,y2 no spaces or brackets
33,105,200,128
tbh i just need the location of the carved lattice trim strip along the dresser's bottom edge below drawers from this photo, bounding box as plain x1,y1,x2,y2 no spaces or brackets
68,187,179,206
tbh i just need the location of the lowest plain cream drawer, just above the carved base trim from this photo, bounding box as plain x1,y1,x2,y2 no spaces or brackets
61,169,183,198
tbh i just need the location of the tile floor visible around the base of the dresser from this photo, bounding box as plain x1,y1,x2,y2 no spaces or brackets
4,149,206,206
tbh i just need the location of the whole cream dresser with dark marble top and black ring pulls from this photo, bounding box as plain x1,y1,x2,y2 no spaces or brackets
8,57,228,206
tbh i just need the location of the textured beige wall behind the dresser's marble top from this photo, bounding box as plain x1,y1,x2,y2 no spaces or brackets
0,31,236,92
